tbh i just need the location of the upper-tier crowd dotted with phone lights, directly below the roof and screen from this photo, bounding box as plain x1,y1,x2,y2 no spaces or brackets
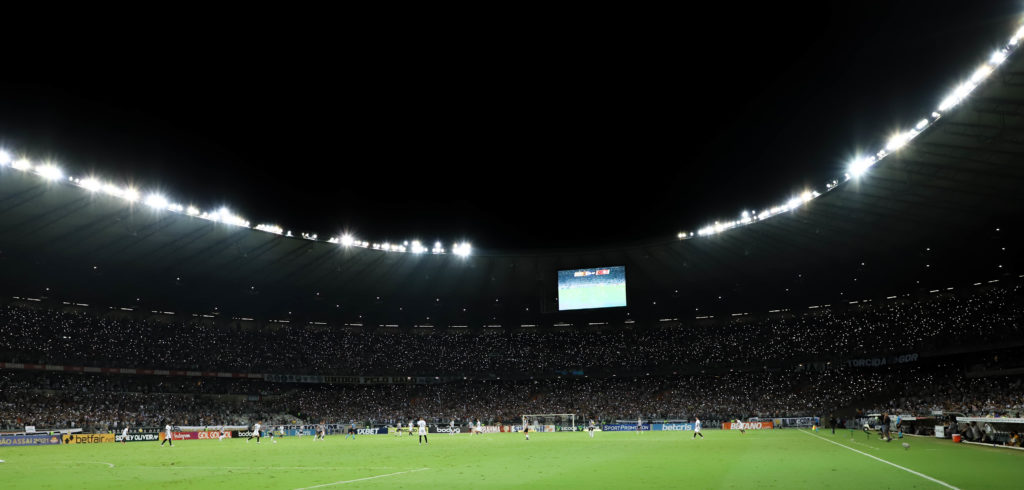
0,285,1024,375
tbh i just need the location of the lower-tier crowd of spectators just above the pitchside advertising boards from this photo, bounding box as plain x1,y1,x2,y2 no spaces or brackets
0,366,1024,430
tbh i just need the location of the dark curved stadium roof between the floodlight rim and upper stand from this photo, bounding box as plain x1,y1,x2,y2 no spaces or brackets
0,35,1024,326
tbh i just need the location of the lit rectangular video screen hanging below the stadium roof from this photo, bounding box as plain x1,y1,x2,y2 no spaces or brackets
558,266,626,311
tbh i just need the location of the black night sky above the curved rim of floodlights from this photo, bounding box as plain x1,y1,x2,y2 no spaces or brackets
0,1,1022,251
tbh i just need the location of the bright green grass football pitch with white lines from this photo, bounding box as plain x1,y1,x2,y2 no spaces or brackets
0,430,1024,489
